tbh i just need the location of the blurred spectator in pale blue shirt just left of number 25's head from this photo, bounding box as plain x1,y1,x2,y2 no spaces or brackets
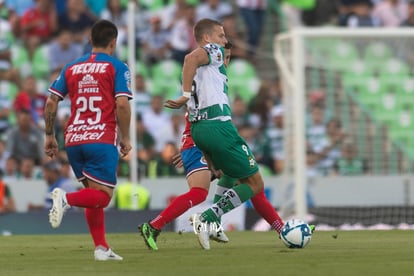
48,29,83,71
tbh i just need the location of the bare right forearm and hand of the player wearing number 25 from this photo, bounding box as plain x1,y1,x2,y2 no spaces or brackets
116,96,131,156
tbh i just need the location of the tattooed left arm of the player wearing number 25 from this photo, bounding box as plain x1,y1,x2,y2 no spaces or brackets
44,94,61,158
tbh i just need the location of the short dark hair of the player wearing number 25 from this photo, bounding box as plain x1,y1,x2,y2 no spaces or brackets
91,20,118,48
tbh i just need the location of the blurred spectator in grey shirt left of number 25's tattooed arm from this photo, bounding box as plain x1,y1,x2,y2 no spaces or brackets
6,109,45,165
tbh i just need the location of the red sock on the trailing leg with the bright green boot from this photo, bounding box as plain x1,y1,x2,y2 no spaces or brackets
150,187,208,230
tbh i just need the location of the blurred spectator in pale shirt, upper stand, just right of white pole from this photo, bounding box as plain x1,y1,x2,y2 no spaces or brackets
141,16,171,67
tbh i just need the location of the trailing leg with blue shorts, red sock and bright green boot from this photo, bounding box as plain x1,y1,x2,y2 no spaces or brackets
139,147,211,250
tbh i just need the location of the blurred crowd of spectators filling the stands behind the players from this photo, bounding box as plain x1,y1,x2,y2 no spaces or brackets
0,0,408,213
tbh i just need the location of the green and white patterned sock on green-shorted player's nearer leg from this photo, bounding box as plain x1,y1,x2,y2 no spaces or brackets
201,184,254,223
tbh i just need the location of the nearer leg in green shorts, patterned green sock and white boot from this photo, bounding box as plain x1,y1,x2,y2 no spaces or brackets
191,121,264,249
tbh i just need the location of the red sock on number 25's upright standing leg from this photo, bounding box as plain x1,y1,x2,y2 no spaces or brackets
85,208,109,249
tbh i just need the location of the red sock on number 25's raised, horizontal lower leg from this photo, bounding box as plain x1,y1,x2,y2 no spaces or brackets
66,188,111,208
